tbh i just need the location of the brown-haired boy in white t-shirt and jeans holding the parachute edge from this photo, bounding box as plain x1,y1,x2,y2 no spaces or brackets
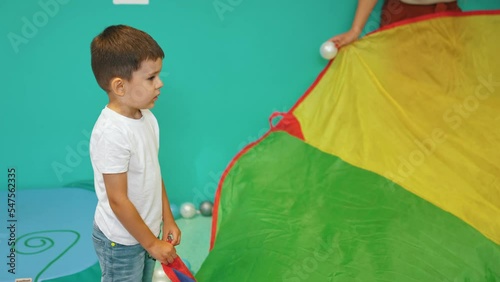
90,25,181,282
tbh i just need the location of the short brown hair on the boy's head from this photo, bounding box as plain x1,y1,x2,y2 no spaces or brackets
90,25,165,92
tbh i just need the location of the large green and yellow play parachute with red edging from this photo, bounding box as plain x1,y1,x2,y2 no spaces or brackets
196,12,500,282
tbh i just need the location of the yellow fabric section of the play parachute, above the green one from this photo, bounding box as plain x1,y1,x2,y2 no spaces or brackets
293,14,500,244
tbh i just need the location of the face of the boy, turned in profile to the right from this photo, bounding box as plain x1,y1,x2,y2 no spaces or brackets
124,58,163,110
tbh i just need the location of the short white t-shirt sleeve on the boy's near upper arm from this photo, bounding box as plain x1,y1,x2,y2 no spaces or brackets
92,126,131,174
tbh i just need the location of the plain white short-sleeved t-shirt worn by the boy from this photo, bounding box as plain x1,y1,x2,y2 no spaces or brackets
90,107,162,245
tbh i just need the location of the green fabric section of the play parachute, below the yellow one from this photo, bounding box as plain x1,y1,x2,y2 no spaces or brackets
196,132,500,282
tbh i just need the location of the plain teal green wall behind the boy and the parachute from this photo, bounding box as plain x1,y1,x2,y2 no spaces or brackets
0,0,500,207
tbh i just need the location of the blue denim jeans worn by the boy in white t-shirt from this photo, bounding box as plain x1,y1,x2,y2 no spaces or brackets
92,224,155,282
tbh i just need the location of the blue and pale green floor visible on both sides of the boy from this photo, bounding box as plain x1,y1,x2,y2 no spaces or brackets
0,187,212,282
